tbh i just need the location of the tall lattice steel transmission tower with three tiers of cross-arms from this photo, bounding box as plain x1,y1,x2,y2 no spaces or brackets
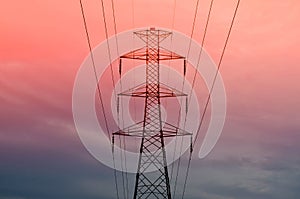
114,28,191,199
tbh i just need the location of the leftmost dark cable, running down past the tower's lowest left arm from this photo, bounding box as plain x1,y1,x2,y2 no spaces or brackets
79,0,119,199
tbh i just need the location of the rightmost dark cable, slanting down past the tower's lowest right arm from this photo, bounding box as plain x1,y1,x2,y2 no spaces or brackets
182,0,240,199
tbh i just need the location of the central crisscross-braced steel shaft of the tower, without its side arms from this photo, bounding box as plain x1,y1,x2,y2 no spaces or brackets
134,30,171,199
